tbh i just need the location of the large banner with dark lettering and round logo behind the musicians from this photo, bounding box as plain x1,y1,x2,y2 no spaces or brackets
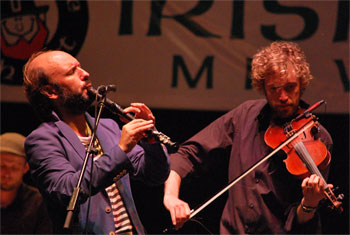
1,0,349,113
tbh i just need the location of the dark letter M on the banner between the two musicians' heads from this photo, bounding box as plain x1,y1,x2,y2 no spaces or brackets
171,55,214,89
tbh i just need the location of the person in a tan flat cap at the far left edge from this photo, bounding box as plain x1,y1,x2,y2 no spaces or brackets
0,132,52,234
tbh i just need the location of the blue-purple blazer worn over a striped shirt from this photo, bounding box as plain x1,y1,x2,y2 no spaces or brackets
25,114,170,234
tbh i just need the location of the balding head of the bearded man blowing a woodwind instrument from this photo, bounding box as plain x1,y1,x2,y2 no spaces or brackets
23,51,90,121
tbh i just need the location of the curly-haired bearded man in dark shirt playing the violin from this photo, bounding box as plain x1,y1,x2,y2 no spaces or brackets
163,41,332,234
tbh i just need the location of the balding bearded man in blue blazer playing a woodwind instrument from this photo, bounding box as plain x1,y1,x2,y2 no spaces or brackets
24,51,169,234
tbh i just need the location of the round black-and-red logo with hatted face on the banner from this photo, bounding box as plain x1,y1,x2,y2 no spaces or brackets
1,0,89,85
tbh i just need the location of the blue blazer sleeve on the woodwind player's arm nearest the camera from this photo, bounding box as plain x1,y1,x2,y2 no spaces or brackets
25,123,133,205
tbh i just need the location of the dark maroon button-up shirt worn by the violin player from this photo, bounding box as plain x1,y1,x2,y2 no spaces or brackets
170,99,332,234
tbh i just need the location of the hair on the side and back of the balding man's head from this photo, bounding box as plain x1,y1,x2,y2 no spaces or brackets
23,50,56,121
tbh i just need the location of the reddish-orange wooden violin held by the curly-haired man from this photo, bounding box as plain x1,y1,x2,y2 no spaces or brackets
264,103,343,212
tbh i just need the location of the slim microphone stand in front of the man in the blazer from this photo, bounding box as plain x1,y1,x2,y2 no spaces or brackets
64,94,106,229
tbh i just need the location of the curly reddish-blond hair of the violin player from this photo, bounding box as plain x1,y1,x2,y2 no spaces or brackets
251,41,313,92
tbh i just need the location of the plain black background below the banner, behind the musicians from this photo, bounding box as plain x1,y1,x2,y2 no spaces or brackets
1,102,349,234
